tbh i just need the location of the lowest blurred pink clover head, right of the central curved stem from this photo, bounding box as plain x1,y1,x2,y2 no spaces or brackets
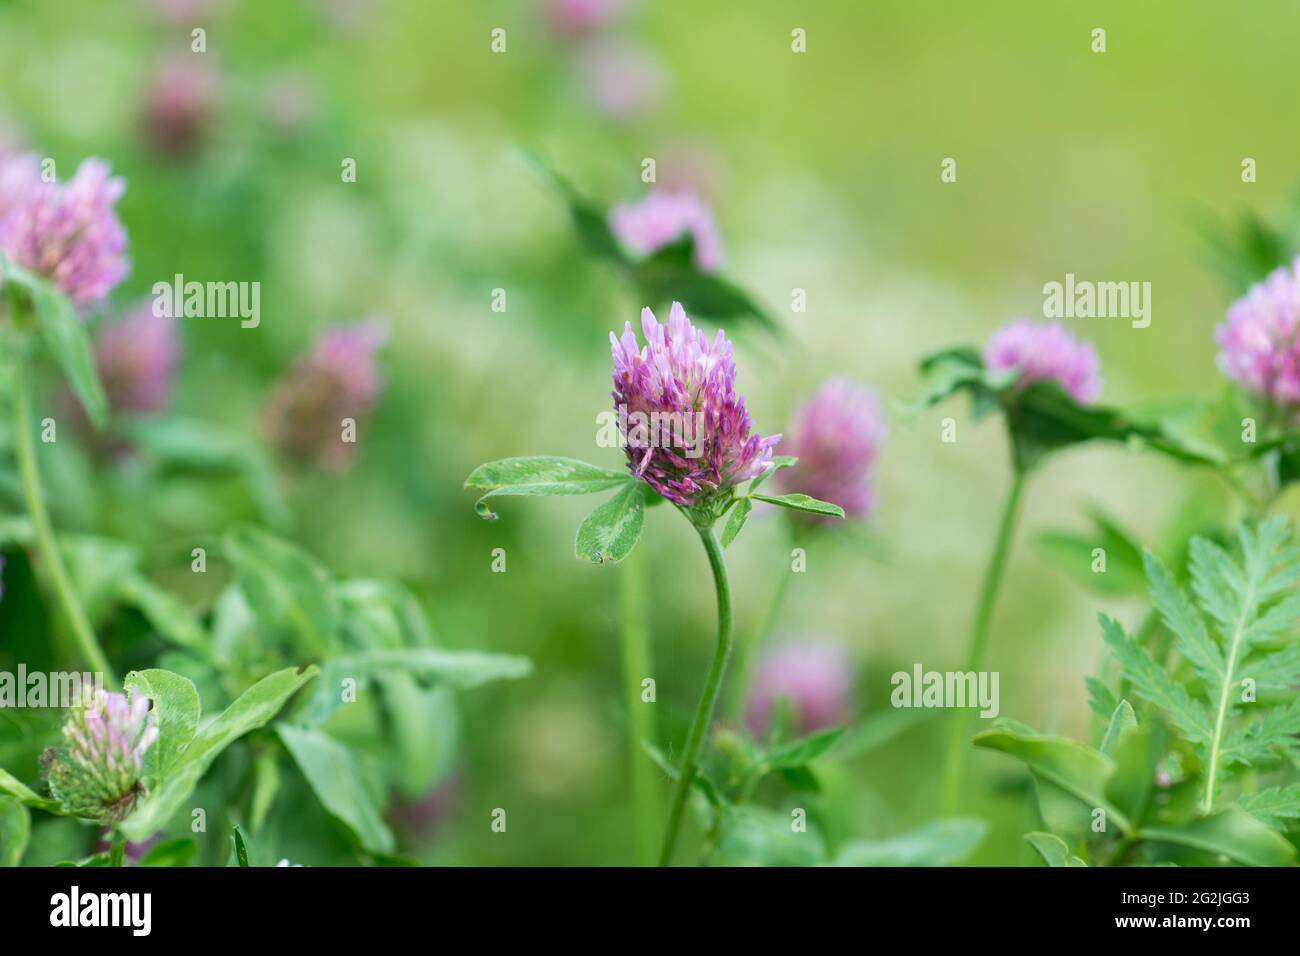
745,640,852,736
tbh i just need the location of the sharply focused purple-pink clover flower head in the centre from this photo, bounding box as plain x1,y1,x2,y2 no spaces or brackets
610,302,781,516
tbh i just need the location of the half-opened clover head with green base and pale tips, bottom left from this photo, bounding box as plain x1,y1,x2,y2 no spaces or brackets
42,691,159,825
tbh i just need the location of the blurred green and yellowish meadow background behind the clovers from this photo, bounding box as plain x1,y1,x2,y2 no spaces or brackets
0,0,1300,865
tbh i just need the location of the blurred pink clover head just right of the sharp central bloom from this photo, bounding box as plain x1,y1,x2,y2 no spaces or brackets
776,378,885,520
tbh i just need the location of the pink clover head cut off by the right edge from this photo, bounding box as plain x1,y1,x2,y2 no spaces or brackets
1214,258,1300,406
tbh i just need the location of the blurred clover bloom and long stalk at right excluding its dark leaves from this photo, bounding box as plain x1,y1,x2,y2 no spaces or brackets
943,319,1101,813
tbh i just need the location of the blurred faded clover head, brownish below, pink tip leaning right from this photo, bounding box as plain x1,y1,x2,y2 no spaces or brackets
267,319,387,467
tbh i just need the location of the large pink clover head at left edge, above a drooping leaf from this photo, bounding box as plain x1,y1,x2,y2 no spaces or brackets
0,159,129,304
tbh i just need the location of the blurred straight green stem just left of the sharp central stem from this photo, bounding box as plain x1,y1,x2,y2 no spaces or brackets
620,550,659,866
